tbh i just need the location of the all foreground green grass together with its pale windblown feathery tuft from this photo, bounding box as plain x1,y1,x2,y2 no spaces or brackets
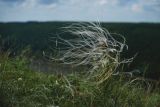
0,24,160,107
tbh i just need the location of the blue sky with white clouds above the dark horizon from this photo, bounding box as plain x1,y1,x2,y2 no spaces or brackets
0,0,160,22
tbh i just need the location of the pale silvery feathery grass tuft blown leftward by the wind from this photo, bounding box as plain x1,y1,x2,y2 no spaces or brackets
53,23,132,83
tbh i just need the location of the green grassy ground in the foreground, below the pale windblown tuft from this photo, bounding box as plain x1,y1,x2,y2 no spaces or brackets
0,54,160,107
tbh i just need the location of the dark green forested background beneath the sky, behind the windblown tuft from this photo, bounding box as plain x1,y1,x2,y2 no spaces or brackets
0,22,160,80
